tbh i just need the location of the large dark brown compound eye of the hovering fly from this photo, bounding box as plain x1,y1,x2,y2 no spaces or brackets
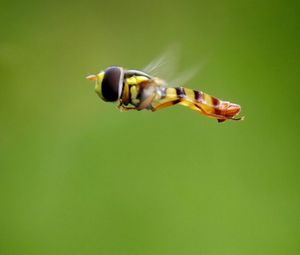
101,66,124,102
